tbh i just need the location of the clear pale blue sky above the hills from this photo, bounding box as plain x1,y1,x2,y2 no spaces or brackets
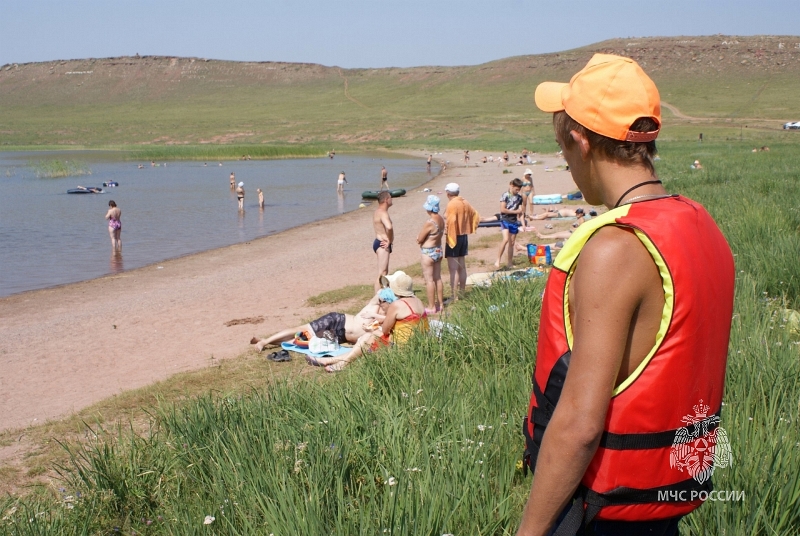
0,0,800,67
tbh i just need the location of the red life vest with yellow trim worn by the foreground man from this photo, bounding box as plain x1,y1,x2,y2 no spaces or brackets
523,196,735,522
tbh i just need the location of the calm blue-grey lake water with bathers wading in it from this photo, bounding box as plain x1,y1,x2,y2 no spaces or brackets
0,152,438,296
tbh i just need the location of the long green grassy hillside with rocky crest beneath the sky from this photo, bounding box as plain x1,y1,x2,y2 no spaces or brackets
0,36,800,150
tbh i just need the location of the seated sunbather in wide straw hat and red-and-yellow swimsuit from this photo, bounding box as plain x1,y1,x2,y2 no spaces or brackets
306,271,428,372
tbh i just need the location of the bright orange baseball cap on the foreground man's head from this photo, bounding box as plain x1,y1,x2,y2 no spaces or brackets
534,54,661,142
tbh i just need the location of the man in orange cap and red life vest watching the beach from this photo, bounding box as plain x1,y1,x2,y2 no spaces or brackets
518,54,734,536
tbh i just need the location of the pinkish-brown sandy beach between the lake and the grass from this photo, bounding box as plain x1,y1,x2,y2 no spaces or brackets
0,151,575,430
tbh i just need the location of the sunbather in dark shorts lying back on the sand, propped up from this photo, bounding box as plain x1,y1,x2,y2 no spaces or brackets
250,289,397,352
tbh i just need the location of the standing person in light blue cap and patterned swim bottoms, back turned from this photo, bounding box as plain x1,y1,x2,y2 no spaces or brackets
417,195,444,314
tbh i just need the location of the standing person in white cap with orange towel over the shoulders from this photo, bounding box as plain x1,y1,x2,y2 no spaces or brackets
444,182,480,301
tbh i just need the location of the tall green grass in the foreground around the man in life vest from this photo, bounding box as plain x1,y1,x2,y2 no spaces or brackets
0,137,800,535
